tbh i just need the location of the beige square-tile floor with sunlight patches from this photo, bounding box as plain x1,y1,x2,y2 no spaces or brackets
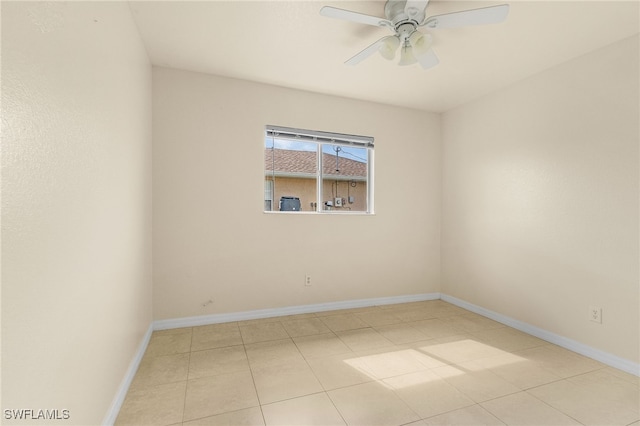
116,300,640,426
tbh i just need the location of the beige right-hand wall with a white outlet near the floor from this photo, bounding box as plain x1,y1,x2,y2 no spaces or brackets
442,36,640,362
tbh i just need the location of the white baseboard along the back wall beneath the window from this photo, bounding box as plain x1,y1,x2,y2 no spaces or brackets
153,293,440,330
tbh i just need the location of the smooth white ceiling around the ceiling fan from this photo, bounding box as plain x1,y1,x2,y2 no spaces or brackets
130,0,640,112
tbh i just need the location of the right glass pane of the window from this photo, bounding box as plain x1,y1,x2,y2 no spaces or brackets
322,144,368,212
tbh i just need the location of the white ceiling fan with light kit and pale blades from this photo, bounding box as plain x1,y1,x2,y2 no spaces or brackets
320,0,509,69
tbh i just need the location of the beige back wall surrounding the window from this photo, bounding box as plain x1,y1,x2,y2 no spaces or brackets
153,68,440,319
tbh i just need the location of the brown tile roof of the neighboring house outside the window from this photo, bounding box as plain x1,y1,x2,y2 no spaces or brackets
264,148,367,177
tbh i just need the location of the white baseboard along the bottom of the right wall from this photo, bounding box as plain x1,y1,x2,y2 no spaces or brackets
440,294,640,376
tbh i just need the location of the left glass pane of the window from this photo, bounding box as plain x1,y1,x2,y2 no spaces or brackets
264,136,318,211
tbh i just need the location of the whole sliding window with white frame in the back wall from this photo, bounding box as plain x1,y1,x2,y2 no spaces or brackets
264,126,373,213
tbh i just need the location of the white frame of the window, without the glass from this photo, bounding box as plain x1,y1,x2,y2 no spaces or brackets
265,125,374,214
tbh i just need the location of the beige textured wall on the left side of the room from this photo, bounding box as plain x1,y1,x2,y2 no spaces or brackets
2,2,151,425
